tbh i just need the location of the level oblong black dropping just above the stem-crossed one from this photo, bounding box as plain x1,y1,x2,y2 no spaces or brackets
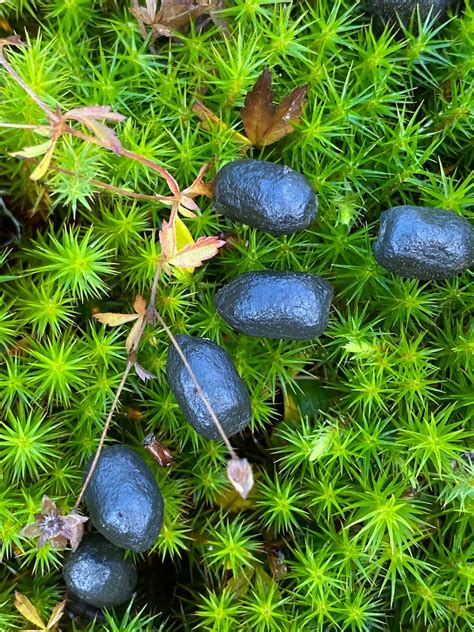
214,270,333,340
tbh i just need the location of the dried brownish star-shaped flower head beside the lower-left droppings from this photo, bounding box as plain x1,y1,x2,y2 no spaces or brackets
20,496,89,551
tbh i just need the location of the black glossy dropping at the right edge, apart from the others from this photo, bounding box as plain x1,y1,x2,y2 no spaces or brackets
374,206,474,280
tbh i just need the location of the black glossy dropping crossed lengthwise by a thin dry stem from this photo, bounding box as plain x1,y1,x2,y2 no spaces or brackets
166,335,252,440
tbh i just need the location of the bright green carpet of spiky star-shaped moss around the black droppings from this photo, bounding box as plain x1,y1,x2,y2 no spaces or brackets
0,0,474,632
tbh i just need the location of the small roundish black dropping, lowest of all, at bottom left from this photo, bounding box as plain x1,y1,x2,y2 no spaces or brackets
63,533,137,608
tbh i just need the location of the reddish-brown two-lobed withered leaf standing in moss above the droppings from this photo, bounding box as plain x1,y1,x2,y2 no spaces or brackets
241,68,308,147
